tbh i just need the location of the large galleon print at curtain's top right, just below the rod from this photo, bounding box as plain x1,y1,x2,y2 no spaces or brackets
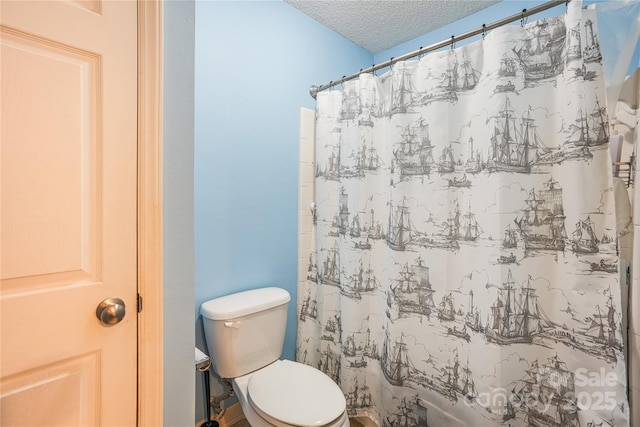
513,19,566,81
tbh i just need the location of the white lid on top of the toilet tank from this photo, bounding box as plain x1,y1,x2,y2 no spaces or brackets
200,287,291,320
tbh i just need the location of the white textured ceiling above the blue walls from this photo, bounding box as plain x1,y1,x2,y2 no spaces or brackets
284,0,499,54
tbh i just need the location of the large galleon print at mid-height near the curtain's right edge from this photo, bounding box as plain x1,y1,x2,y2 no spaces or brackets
514,178,567,251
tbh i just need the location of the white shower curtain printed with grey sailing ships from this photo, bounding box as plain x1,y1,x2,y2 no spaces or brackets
297,1,629,427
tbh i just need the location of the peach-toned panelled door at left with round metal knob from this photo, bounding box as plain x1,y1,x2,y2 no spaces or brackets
0,0,137,427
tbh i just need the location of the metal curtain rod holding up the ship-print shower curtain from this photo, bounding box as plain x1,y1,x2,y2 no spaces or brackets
309,0,571,99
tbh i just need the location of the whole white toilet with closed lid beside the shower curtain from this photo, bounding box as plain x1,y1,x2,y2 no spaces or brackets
200,287,349,427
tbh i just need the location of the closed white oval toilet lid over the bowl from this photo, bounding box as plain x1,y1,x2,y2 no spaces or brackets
247,360,346,427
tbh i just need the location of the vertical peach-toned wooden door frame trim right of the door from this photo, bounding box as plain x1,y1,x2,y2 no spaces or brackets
137,0,163,427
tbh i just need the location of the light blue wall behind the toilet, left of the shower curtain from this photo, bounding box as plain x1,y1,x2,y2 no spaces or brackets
192,1,372,418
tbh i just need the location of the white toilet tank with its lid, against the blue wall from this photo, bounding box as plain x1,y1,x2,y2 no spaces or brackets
200,287,291,378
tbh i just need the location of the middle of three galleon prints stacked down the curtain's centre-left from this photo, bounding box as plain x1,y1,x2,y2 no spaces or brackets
391,257,436,317
